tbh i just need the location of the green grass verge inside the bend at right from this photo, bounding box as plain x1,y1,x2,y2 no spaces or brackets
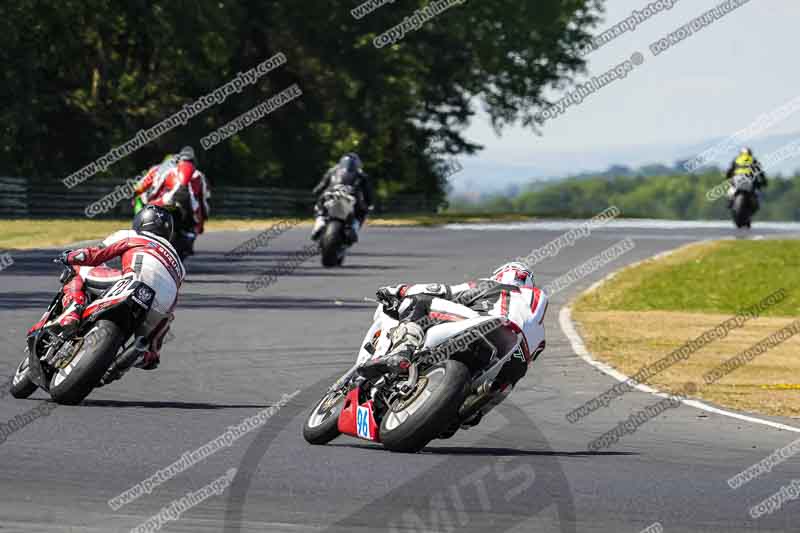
575,240,800,316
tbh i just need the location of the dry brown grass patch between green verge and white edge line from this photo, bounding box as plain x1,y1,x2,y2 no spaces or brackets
573,308,800,417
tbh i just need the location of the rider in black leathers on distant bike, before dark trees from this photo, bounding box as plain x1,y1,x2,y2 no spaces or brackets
311,152,375,243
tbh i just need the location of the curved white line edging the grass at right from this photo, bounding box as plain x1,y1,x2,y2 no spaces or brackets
558,241,800,433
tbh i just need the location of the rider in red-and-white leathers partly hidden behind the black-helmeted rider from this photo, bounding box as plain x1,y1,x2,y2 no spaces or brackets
135,146,210,235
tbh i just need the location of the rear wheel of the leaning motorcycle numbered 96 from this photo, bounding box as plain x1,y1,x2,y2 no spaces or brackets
380,360,469,453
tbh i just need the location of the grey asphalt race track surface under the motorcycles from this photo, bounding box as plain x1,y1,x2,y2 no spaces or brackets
0,218,800,533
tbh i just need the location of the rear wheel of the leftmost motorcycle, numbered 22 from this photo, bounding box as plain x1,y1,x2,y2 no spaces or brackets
50,320,125,405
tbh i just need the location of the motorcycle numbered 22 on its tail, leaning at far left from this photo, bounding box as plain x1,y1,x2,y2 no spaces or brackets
10,259,155,405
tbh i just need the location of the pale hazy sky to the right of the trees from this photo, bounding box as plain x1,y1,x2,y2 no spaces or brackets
451,0,800,189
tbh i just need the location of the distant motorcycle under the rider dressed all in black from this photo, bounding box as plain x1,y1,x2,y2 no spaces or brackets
319,185,358,267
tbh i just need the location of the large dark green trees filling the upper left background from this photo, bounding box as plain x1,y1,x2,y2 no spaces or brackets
0,0,606,205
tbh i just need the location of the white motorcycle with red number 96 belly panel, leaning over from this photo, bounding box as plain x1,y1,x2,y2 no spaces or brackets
303,302,523,453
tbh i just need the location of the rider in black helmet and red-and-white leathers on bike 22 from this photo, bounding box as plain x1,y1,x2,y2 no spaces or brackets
38,205,186,370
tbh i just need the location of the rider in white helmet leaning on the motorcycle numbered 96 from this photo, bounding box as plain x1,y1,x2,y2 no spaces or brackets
358,262,548,427
